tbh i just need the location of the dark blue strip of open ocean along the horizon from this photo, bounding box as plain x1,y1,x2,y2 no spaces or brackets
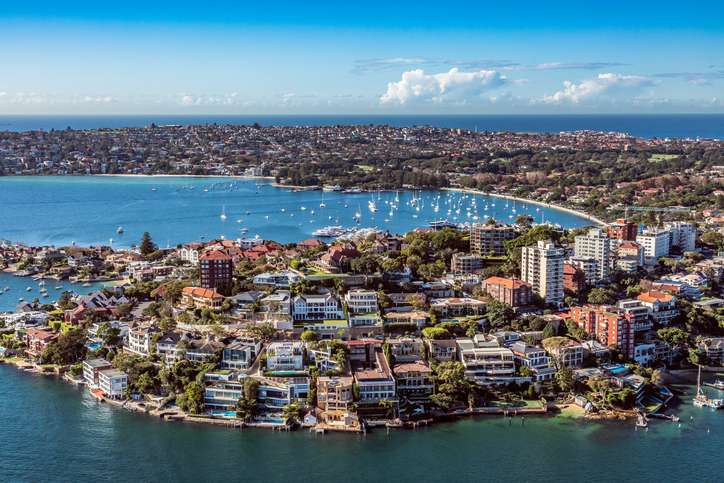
0,114,724,139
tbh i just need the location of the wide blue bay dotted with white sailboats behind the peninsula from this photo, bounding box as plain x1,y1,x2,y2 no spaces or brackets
0,176,590,250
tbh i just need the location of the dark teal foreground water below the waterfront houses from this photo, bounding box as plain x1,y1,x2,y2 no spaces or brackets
0,365,724,483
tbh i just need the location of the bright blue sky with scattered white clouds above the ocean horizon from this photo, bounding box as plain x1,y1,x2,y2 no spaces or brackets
0,0,724,115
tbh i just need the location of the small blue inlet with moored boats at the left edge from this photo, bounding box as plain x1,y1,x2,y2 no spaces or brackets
0,272,103,312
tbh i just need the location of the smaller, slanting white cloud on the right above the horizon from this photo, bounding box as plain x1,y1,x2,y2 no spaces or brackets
543,73,655,104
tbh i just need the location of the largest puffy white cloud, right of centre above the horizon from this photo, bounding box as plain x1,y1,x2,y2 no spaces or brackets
380,68,508,105
